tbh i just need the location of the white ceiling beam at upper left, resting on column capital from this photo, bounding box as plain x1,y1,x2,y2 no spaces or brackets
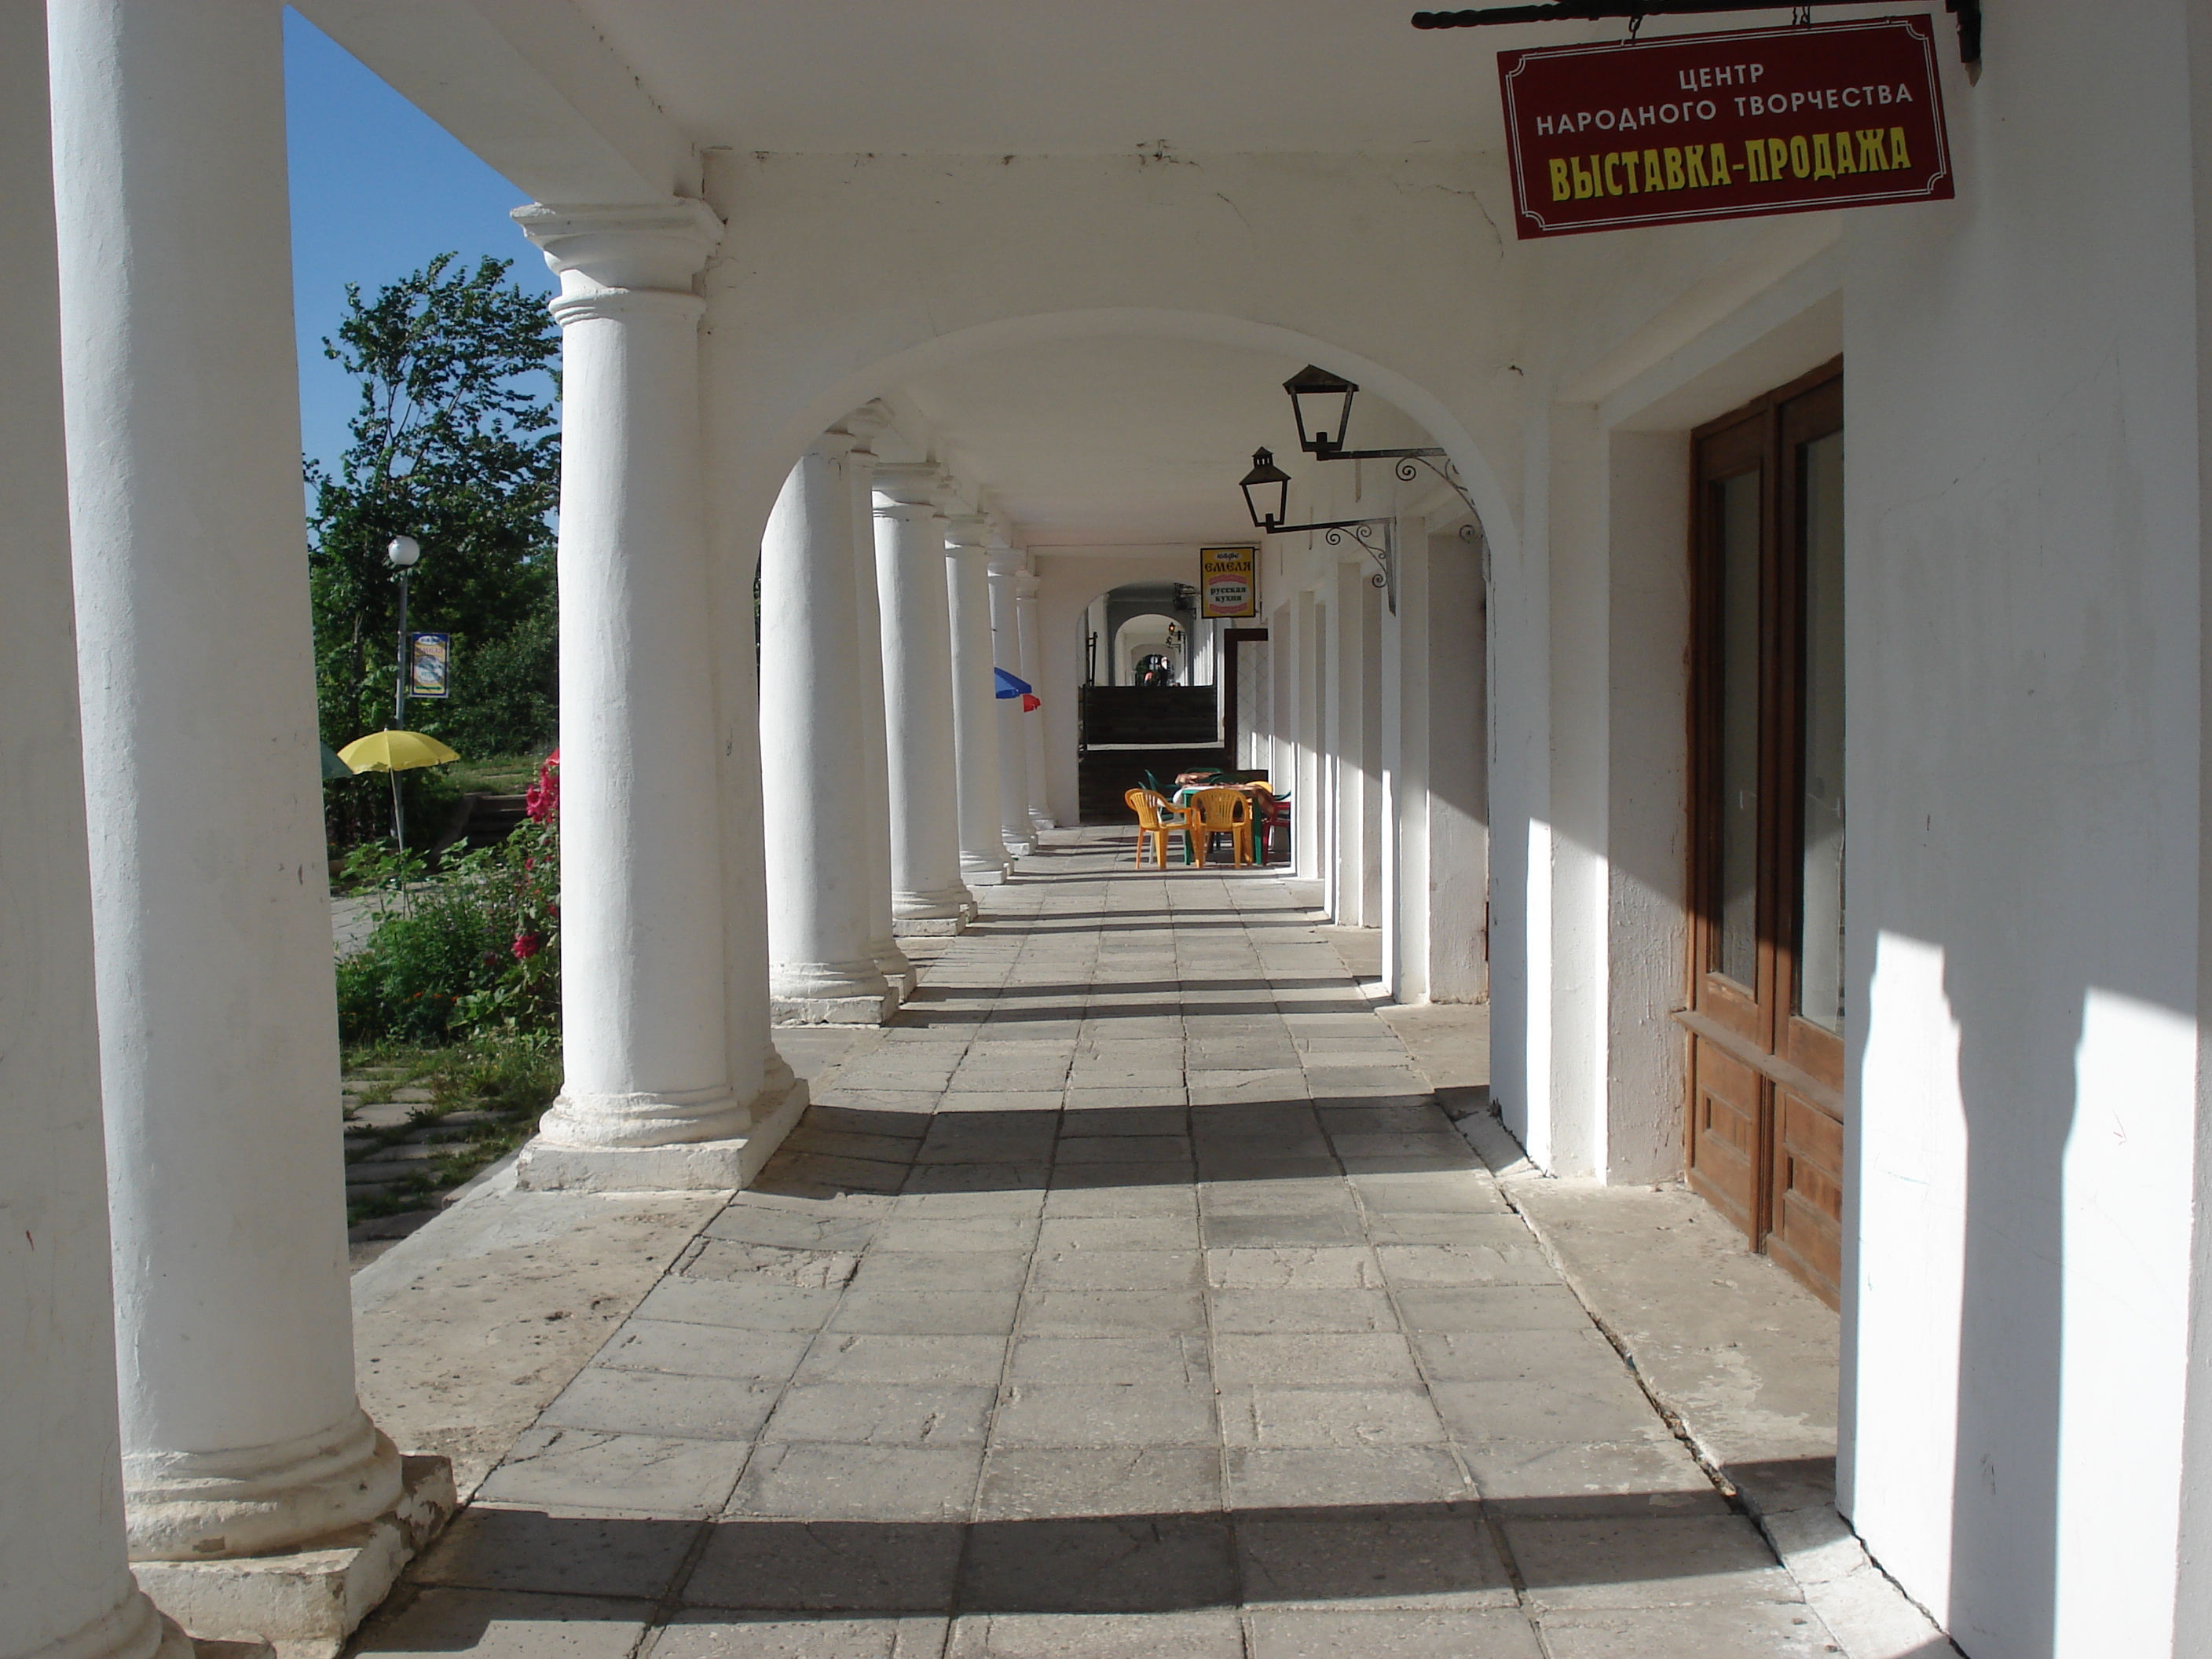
295,0,699,206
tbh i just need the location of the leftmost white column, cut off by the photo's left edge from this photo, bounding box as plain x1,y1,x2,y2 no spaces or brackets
0,0,192,1659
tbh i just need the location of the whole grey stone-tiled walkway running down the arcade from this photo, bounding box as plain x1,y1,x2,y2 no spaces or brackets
361,834,1840,1659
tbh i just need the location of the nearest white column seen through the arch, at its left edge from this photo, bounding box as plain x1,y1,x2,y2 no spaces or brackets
761,434,898,1024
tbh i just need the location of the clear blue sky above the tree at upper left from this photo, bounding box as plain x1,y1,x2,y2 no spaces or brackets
283,11,553,480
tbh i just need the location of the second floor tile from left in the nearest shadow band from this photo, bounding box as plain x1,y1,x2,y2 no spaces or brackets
683,1515,962,1613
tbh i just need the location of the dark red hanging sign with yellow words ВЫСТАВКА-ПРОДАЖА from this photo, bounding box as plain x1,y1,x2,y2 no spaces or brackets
1497,18,1954,239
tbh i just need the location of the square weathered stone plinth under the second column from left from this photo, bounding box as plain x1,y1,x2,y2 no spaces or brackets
135,1458,456,1659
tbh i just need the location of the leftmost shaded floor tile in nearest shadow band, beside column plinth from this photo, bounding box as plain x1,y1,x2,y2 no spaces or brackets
407,1504,705,1602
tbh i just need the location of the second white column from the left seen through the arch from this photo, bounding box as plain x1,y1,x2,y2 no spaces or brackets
876,463,976,933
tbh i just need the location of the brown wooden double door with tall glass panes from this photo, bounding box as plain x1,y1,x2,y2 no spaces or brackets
1683,365,1847,1303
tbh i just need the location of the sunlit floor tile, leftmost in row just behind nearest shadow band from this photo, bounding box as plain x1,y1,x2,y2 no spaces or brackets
478,1426,750,1518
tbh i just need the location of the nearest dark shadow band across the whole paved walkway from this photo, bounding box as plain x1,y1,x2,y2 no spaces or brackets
376,1486,1831,1653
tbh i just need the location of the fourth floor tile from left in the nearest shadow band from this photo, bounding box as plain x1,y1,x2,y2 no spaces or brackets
1236,1504,1513,1610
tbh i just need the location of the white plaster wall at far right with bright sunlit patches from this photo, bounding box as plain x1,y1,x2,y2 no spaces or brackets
1843,2,2203,1659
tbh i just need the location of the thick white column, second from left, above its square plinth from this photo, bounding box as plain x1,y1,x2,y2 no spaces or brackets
49,0,401,1584
